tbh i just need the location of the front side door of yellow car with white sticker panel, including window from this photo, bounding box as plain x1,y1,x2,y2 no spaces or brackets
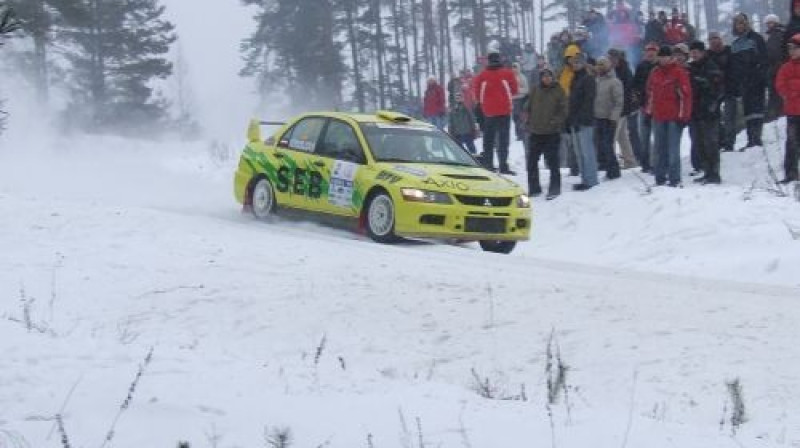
311,118,366,216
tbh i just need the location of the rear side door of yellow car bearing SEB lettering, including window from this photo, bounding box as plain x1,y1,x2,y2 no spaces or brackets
275,117,328,209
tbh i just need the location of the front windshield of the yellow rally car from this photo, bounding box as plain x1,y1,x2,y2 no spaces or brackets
361,123,478,166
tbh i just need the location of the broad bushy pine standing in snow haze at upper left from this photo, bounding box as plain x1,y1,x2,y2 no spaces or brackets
65,0,176,131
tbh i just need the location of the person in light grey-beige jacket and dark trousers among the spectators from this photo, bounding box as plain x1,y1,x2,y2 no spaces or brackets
594,56,625,180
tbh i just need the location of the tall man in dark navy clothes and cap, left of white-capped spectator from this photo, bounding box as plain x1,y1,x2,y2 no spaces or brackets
728,13,767,151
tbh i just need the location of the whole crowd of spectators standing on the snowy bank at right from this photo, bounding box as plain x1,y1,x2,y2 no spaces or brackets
423,0,800,199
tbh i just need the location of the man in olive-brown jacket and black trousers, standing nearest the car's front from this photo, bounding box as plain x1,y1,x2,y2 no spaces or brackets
528,69,569,200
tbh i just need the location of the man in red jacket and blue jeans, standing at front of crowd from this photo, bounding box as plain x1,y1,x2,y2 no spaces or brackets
646,46,692,187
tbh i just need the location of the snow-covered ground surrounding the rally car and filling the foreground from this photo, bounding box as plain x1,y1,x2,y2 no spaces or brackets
0,123,800,448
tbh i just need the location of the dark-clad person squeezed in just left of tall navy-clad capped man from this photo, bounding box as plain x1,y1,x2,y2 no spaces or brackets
706,31,739,152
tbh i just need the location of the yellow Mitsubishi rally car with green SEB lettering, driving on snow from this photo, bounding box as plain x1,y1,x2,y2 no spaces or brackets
234,111,531,253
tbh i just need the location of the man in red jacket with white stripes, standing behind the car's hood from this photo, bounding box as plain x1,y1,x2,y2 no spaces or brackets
472,52,519,175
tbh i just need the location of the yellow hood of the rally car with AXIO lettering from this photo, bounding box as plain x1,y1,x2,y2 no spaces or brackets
377,162,524,195
